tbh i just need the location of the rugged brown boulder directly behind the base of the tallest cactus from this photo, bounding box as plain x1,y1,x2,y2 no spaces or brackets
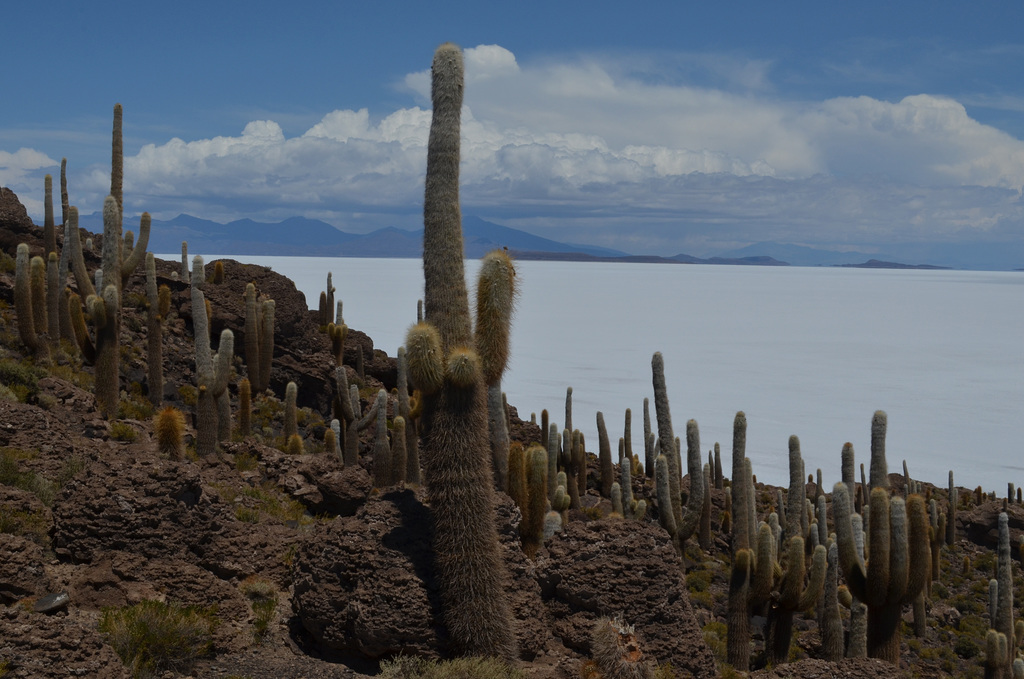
293,490,554,660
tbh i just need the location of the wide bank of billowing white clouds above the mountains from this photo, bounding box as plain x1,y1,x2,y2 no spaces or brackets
68,45,1024,252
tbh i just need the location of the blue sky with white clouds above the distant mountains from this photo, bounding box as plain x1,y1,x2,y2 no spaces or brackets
0,0,1024,266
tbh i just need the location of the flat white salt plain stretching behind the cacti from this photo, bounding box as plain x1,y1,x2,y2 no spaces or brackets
178,255,1024,494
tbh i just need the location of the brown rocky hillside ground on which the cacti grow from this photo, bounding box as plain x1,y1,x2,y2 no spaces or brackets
0,190,1024,679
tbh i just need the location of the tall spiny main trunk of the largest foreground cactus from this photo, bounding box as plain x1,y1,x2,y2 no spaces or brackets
407,43,516,659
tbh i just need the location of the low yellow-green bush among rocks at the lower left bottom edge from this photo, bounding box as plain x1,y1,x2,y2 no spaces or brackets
99,601,218,679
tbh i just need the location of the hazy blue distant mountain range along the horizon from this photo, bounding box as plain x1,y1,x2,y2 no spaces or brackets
79,212,1024,269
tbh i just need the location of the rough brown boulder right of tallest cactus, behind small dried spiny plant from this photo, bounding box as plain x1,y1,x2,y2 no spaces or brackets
537,519,718,678
